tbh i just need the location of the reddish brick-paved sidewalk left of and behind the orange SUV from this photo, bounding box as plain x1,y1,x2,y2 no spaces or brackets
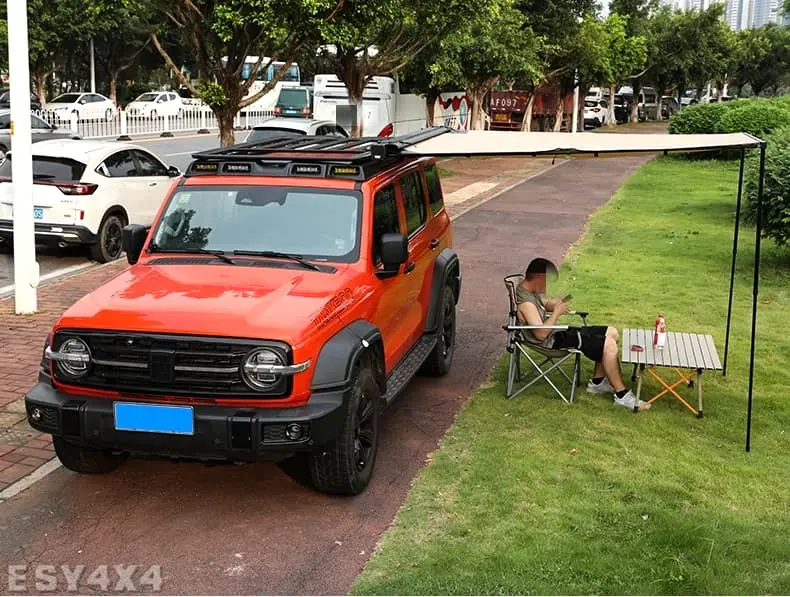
0,157,562,499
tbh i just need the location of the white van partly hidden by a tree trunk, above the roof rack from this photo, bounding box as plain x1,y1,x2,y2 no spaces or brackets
313,75,396,137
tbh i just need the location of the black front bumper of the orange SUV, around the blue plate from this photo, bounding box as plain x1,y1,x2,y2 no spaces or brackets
25,380,350,461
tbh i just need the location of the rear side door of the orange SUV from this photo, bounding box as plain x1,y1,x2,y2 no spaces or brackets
398,169,433,346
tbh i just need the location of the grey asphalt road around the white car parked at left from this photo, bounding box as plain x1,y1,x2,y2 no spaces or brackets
0,131,223,296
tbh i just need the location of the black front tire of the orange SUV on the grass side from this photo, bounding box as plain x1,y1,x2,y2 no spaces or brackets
308,364,381,495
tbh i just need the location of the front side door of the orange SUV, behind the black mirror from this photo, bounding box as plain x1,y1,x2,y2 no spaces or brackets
371,183,411,371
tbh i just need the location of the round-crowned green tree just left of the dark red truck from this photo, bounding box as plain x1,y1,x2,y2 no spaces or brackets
430,0,540,129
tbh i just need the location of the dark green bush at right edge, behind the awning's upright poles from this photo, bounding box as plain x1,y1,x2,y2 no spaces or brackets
743,126,790,246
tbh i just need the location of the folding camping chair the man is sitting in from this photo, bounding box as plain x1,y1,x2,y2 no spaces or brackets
502,274,588,404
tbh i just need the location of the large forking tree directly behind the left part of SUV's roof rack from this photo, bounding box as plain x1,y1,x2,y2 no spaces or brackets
147,0,344,145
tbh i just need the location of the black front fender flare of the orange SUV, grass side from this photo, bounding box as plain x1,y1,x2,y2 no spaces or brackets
310,319,387,396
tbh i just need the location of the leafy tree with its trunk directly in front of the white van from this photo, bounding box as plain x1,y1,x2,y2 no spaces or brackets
322,0,493,136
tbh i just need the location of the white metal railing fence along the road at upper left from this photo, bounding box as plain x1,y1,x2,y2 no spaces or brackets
34,106,282,139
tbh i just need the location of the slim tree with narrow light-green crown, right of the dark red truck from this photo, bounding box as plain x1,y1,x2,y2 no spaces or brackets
602,12,647,126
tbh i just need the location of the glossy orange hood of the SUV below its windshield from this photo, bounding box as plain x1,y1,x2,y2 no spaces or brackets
58,264,365,345
